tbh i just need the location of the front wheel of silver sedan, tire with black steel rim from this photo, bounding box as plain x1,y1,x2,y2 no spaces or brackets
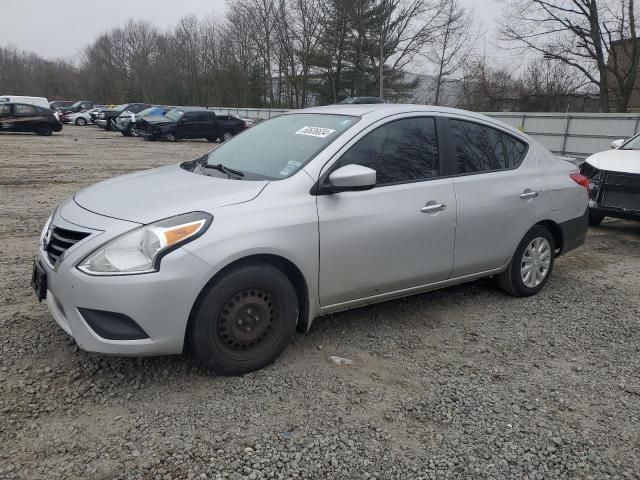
187,263,298,375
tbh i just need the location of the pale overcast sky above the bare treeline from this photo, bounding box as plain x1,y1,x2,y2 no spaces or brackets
0,0,500,60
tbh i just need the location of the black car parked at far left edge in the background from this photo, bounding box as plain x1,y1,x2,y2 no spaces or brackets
0,103,62,135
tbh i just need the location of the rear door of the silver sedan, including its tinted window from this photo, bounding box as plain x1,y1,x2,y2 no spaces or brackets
448,118,542,277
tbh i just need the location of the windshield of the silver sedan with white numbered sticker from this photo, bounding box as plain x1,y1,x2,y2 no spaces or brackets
207,113,359,180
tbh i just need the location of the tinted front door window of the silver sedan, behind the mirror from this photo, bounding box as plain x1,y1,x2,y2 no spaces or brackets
336,118,440,185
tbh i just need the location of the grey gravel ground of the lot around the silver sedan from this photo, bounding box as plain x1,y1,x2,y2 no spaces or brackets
0,126,640,479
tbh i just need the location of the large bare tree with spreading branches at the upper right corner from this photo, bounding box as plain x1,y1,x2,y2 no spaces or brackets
500,0,640,112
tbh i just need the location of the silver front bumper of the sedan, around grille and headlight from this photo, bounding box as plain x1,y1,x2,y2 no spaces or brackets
37,200,211,356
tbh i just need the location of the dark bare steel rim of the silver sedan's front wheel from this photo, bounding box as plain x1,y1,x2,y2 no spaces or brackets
215,288,278,354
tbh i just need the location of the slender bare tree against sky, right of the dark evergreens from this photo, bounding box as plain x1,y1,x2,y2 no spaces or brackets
426,0,480,105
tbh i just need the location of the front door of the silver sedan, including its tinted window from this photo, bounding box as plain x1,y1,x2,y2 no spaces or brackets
317,117,456,306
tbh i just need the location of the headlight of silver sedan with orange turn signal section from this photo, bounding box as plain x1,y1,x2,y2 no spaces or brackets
78,212,213,275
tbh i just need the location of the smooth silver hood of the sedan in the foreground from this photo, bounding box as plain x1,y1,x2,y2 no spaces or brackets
74,165,269,224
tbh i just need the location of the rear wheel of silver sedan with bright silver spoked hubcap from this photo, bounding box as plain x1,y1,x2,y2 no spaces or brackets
498,225,556,297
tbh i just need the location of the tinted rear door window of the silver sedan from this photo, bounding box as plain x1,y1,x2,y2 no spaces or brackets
451,119,527,174
